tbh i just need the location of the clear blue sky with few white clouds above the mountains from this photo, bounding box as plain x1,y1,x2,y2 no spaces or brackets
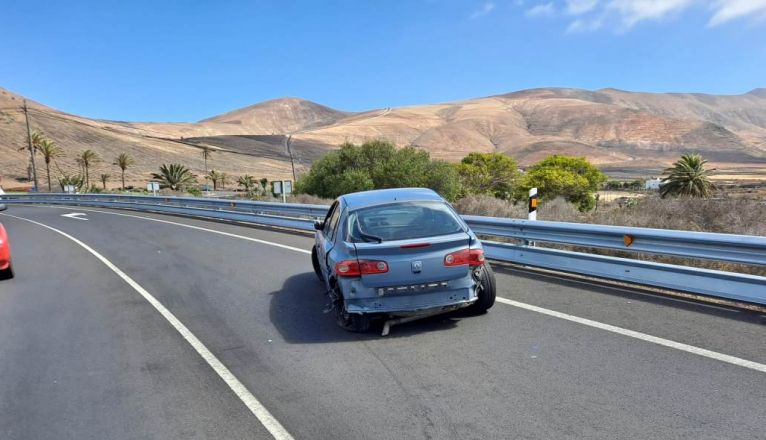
0,0,766,121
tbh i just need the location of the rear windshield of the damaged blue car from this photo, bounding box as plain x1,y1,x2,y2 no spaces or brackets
348,202,463,243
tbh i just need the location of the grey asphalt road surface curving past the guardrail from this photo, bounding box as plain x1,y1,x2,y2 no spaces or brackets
0,206,766,439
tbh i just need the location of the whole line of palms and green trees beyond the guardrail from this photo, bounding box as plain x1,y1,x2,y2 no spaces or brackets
19,131,715,206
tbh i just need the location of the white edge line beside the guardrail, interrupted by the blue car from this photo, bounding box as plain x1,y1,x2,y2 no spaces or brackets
16,206,766,373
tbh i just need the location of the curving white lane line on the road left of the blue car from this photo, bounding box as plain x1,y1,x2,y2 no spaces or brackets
2,214,293,440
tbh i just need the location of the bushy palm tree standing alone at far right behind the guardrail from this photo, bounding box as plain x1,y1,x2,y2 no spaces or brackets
660,154,715,198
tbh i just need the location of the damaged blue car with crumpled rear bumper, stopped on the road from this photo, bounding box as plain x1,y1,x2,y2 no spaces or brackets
311,188,495,335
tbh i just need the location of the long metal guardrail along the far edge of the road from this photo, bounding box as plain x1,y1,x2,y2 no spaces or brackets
2,194,766,305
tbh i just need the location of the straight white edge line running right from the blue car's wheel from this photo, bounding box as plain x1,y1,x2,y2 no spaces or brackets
497,297,766,373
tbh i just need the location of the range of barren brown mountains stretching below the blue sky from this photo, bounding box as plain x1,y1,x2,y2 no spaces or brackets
0,88,766,186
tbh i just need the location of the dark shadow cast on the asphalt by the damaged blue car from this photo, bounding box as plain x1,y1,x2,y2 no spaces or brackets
269,272,472,344
